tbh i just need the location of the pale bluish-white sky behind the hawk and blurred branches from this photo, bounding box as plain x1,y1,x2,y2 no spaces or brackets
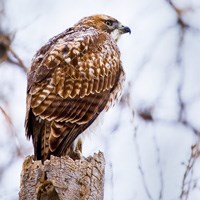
0,0,200,200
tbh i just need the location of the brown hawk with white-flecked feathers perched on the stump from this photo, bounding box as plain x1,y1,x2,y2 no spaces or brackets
25,15,131,161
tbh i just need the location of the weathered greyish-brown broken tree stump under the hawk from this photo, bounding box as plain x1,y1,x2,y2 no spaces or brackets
19,152,105,200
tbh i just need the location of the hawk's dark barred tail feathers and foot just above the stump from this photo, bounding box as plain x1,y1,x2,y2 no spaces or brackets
25,109,82,162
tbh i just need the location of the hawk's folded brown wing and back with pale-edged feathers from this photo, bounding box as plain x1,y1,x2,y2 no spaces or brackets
26,27,123,160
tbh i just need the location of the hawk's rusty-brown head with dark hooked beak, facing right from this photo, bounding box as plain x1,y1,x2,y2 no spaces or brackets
75,15,131,41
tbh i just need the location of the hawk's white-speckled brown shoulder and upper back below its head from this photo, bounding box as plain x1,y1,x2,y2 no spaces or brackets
28,26,120,93
